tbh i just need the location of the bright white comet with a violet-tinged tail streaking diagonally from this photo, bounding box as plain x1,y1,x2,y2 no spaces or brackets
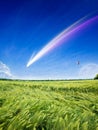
27,15,98,67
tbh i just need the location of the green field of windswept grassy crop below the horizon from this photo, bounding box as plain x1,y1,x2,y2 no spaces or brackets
0,80,98,130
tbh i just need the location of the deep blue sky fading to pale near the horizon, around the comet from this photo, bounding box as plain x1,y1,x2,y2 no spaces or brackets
0,0,98,79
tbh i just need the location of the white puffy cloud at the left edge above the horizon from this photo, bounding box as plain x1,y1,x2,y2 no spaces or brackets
0,61,13,78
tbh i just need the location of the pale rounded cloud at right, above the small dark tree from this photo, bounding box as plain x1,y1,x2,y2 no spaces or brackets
79,63,98,79
